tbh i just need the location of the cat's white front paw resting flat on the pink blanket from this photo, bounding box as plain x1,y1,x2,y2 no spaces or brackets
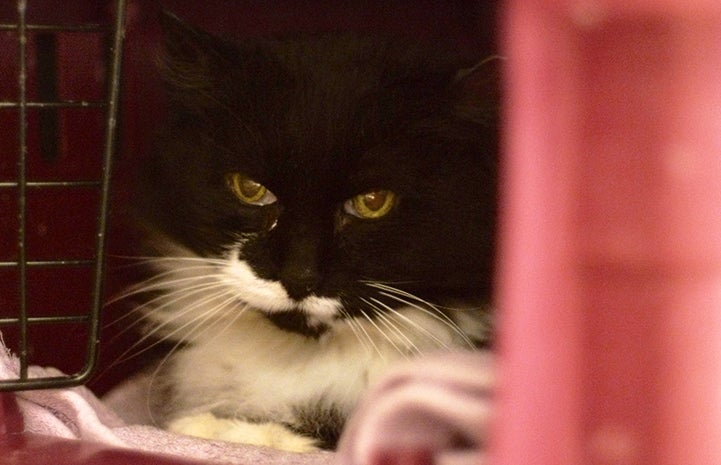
168,413,320,452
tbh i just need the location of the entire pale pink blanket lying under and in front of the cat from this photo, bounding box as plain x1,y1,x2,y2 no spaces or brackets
0,338,493,465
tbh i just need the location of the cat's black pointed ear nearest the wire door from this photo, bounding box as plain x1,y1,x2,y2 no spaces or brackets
158,11,227,107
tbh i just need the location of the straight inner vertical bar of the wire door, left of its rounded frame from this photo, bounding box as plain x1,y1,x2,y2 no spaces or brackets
17,0,28,380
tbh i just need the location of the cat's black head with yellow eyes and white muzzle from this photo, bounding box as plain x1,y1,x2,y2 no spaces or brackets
143,14,497,335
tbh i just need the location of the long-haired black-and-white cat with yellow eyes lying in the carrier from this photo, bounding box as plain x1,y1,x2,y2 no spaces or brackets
125,14,498,452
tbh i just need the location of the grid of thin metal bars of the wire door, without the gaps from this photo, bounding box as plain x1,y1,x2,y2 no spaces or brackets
0,0,125,391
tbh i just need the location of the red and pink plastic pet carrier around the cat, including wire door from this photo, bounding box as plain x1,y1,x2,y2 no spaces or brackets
0,0,721,465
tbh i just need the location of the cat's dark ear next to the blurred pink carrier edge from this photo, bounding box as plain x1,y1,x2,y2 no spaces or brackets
452,55,504,119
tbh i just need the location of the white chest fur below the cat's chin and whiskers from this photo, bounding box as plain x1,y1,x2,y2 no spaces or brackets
162,308,470,423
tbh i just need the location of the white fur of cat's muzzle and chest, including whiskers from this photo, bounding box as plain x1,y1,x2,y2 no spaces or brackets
135,249,488,438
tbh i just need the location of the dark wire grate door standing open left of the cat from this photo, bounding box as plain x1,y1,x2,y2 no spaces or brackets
0,0,125,391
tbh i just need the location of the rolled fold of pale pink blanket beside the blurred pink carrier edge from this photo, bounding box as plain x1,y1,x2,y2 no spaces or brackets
338,352,494,465
